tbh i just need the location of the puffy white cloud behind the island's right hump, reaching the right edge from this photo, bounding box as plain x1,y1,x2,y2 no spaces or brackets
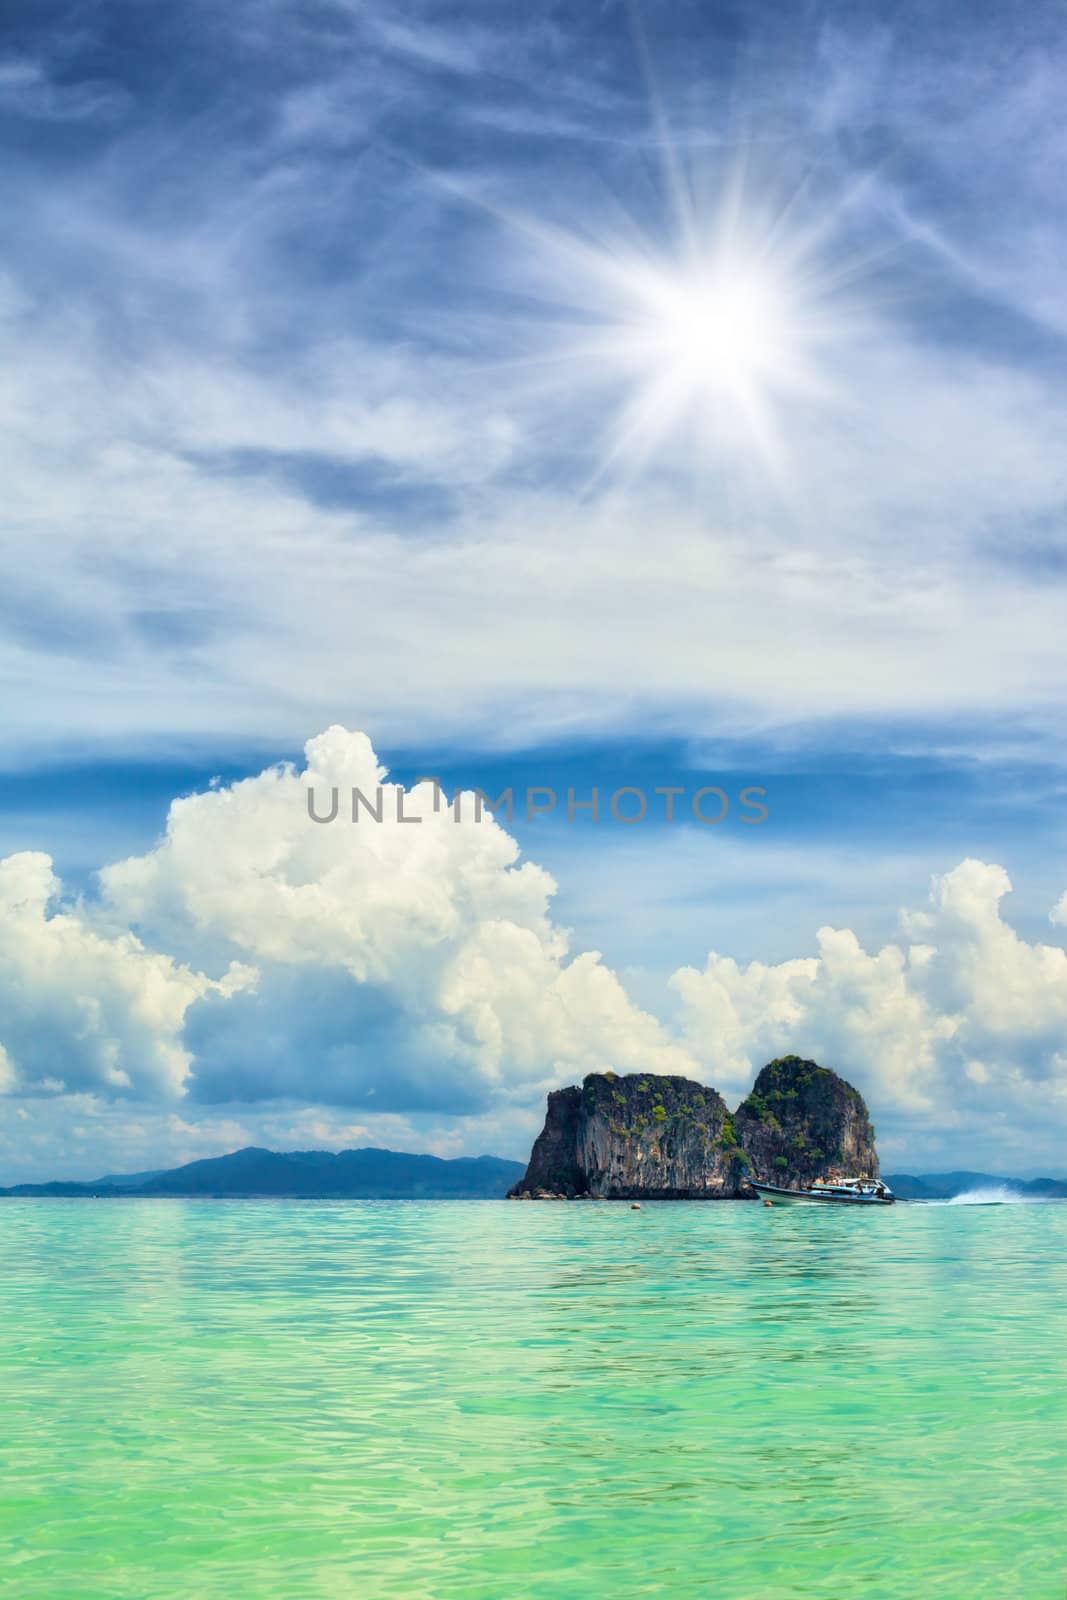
672,859,1067,1160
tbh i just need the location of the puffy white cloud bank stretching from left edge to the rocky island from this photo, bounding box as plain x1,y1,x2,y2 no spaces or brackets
0,728,693,1139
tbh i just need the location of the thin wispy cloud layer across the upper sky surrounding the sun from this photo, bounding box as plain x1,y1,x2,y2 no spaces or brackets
0,6,1067,760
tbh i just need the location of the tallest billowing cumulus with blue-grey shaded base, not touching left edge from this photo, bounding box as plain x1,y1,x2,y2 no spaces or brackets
93,726,693,1110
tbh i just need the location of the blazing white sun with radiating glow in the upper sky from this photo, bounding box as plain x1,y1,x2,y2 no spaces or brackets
495,172,848,474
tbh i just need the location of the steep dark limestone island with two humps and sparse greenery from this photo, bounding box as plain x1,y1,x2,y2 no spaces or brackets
509,1056,878,1200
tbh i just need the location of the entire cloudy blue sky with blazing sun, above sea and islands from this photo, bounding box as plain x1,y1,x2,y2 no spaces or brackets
0,0,1067,1182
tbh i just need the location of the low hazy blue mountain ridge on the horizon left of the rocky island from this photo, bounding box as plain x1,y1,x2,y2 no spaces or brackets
0,1146,523,1200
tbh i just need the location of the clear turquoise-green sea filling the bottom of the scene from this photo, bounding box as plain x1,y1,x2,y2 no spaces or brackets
0,1200,1067,1600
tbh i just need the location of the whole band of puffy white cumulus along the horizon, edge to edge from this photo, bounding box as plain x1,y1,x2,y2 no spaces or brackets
0,728,1067,1170
